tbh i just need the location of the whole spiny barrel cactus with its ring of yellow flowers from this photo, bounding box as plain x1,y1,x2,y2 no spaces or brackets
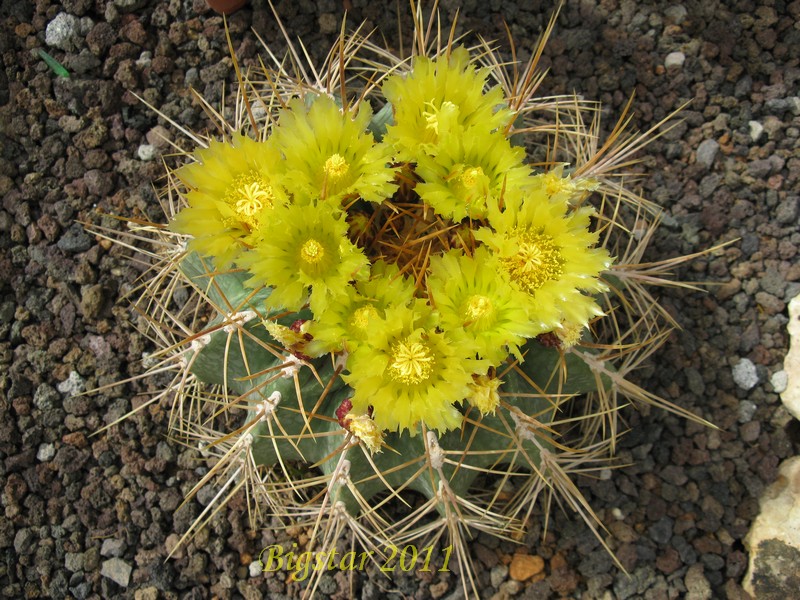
108,5,712,595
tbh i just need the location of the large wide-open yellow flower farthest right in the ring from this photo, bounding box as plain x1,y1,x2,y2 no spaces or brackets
475,187,611,333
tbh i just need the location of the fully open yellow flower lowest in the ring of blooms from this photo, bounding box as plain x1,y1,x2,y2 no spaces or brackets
343,301,479,434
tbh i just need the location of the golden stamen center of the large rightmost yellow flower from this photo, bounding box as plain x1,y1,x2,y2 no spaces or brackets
503,231,564,294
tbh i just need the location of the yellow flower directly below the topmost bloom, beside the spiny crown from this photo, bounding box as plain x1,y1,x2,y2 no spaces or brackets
416,127,531,221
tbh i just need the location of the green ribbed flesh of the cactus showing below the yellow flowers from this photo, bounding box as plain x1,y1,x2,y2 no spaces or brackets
182,253,608,515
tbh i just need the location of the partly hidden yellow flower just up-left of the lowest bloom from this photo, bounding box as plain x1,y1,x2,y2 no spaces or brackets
306,261,414,356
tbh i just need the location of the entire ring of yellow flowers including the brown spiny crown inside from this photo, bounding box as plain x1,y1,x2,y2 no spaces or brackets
173,48,611,440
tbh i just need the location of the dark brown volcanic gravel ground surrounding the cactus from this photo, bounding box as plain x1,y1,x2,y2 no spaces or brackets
0,0,800,600
